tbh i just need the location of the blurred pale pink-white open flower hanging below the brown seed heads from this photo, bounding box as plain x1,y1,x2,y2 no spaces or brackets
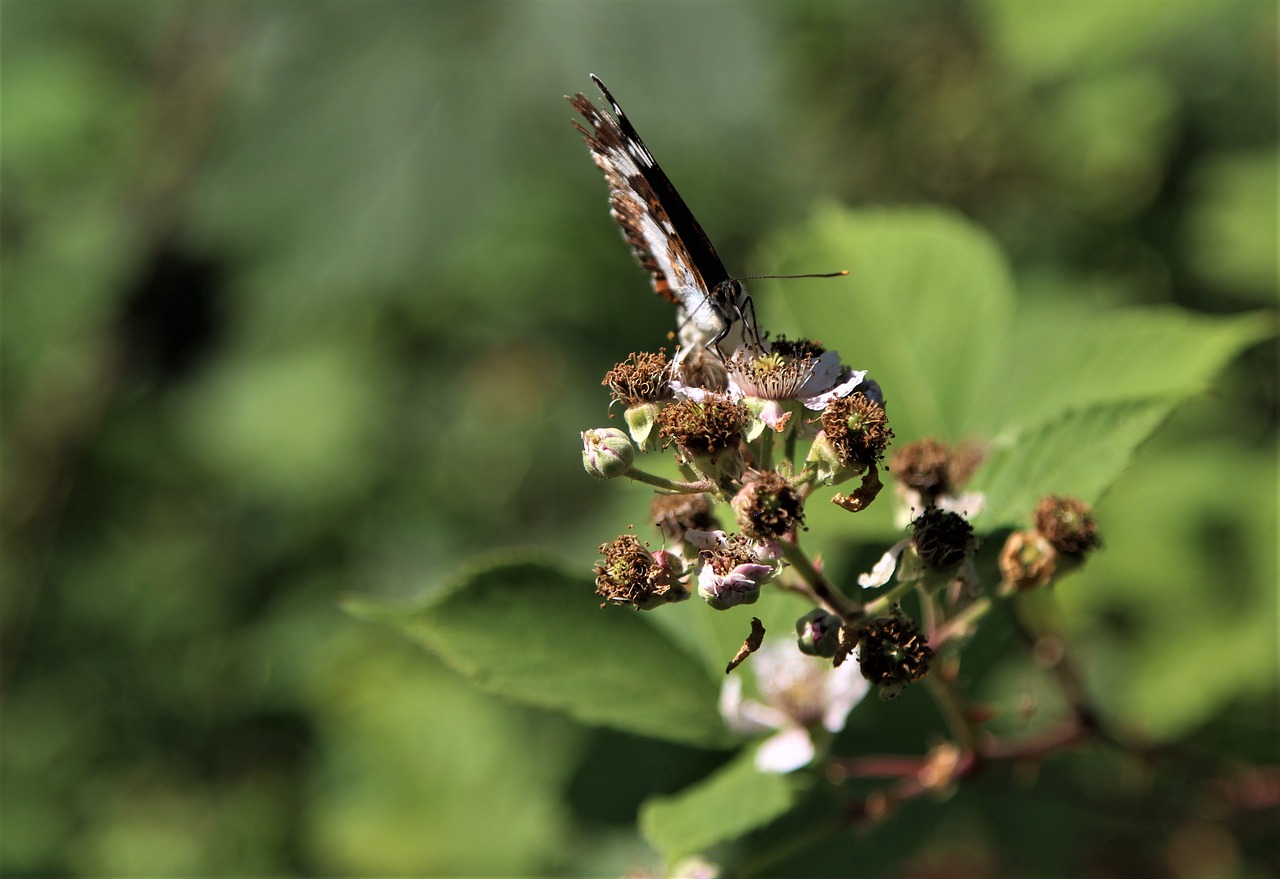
719,645,870,773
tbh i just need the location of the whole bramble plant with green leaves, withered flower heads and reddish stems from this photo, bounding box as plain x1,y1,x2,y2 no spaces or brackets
349,207,1270,875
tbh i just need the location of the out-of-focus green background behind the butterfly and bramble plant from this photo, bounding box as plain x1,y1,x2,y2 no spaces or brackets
0,0,1277,875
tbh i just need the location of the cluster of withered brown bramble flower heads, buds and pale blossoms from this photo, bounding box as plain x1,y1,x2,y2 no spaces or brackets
582,321,1098,772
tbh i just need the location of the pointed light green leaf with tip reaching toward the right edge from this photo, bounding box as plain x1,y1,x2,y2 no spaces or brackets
973,310,1272,526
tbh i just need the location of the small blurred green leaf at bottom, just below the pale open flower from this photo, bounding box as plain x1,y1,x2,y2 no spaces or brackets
640,748,808,861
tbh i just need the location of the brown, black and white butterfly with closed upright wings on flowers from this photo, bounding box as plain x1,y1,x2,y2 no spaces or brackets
568,73,759,356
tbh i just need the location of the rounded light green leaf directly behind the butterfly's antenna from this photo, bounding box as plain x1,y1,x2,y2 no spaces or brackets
762,207,1014,443
